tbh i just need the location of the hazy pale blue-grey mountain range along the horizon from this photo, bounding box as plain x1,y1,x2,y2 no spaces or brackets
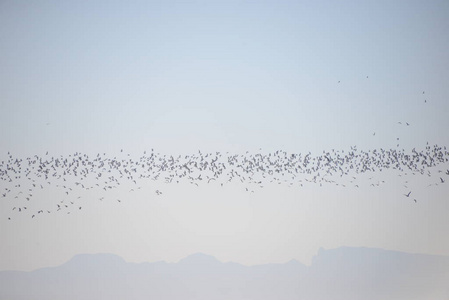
0,247,449,300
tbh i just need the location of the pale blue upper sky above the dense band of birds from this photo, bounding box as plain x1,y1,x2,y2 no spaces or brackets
0,1,449,155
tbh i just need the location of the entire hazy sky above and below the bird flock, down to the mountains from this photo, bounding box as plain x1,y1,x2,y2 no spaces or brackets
0,1,449,270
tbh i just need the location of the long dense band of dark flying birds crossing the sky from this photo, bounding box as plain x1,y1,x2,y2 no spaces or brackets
0,145,449,220
